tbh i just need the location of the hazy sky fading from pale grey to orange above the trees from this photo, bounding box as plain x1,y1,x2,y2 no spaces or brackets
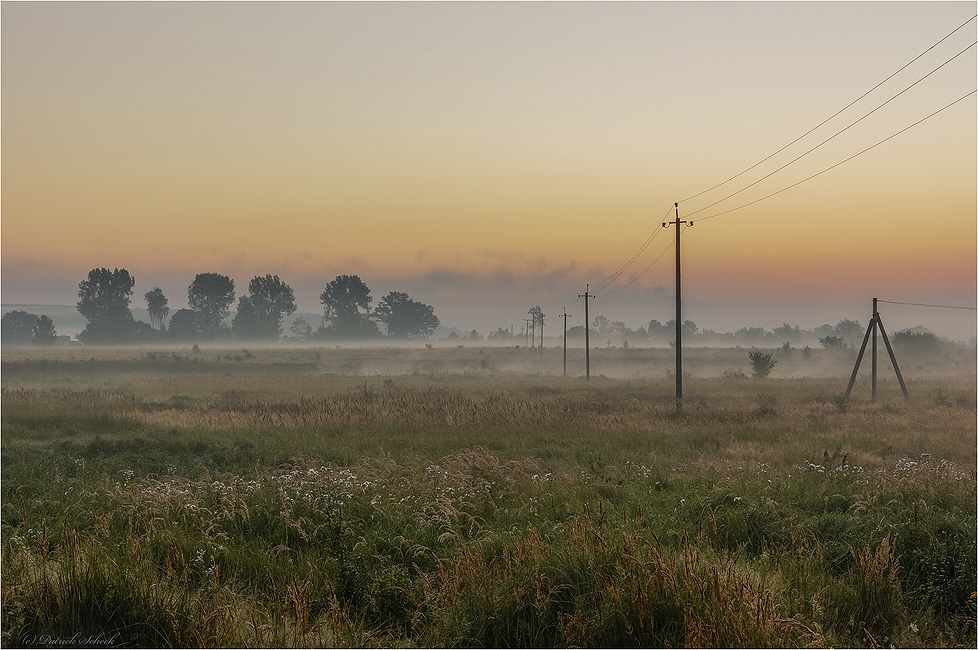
0,2,978,340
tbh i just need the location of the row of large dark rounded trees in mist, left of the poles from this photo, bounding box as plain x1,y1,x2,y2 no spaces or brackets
3,268,439,344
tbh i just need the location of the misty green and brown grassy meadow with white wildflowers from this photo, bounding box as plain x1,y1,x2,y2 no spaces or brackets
0,347,978,647
